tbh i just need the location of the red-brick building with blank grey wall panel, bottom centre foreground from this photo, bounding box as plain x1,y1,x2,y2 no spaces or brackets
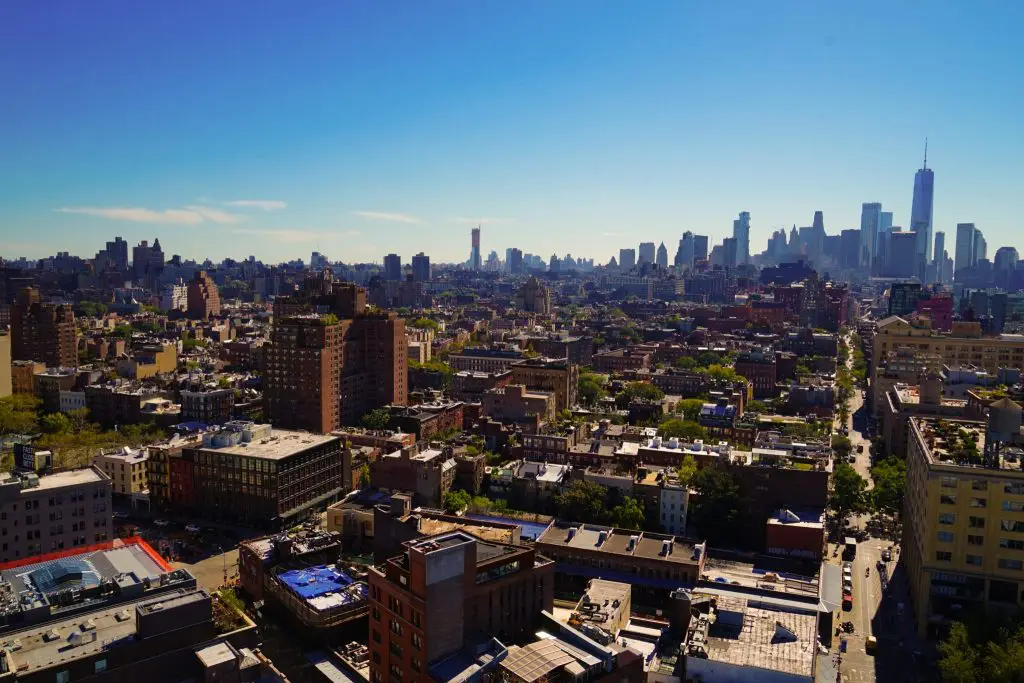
369,531,554,683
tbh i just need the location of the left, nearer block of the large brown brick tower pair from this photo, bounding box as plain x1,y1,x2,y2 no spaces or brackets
263,314,343,434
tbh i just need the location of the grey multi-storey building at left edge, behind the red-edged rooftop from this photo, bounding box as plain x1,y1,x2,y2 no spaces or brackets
0,467,113,562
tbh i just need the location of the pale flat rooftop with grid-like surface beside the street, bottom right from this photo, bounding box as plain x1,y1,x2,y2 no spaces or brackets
685,591,817,677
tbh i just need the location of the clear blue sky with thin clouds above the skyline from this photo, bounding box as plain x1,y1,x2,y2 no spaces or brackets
0,0,1024,263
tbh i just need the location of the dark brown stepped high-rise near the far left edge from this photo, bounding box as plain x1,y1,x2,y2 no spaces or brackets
10,287,78,368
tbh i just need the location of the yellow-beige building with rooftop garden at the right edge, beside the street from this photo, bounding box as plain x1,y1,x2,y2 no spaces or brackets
902,399,1024,635
